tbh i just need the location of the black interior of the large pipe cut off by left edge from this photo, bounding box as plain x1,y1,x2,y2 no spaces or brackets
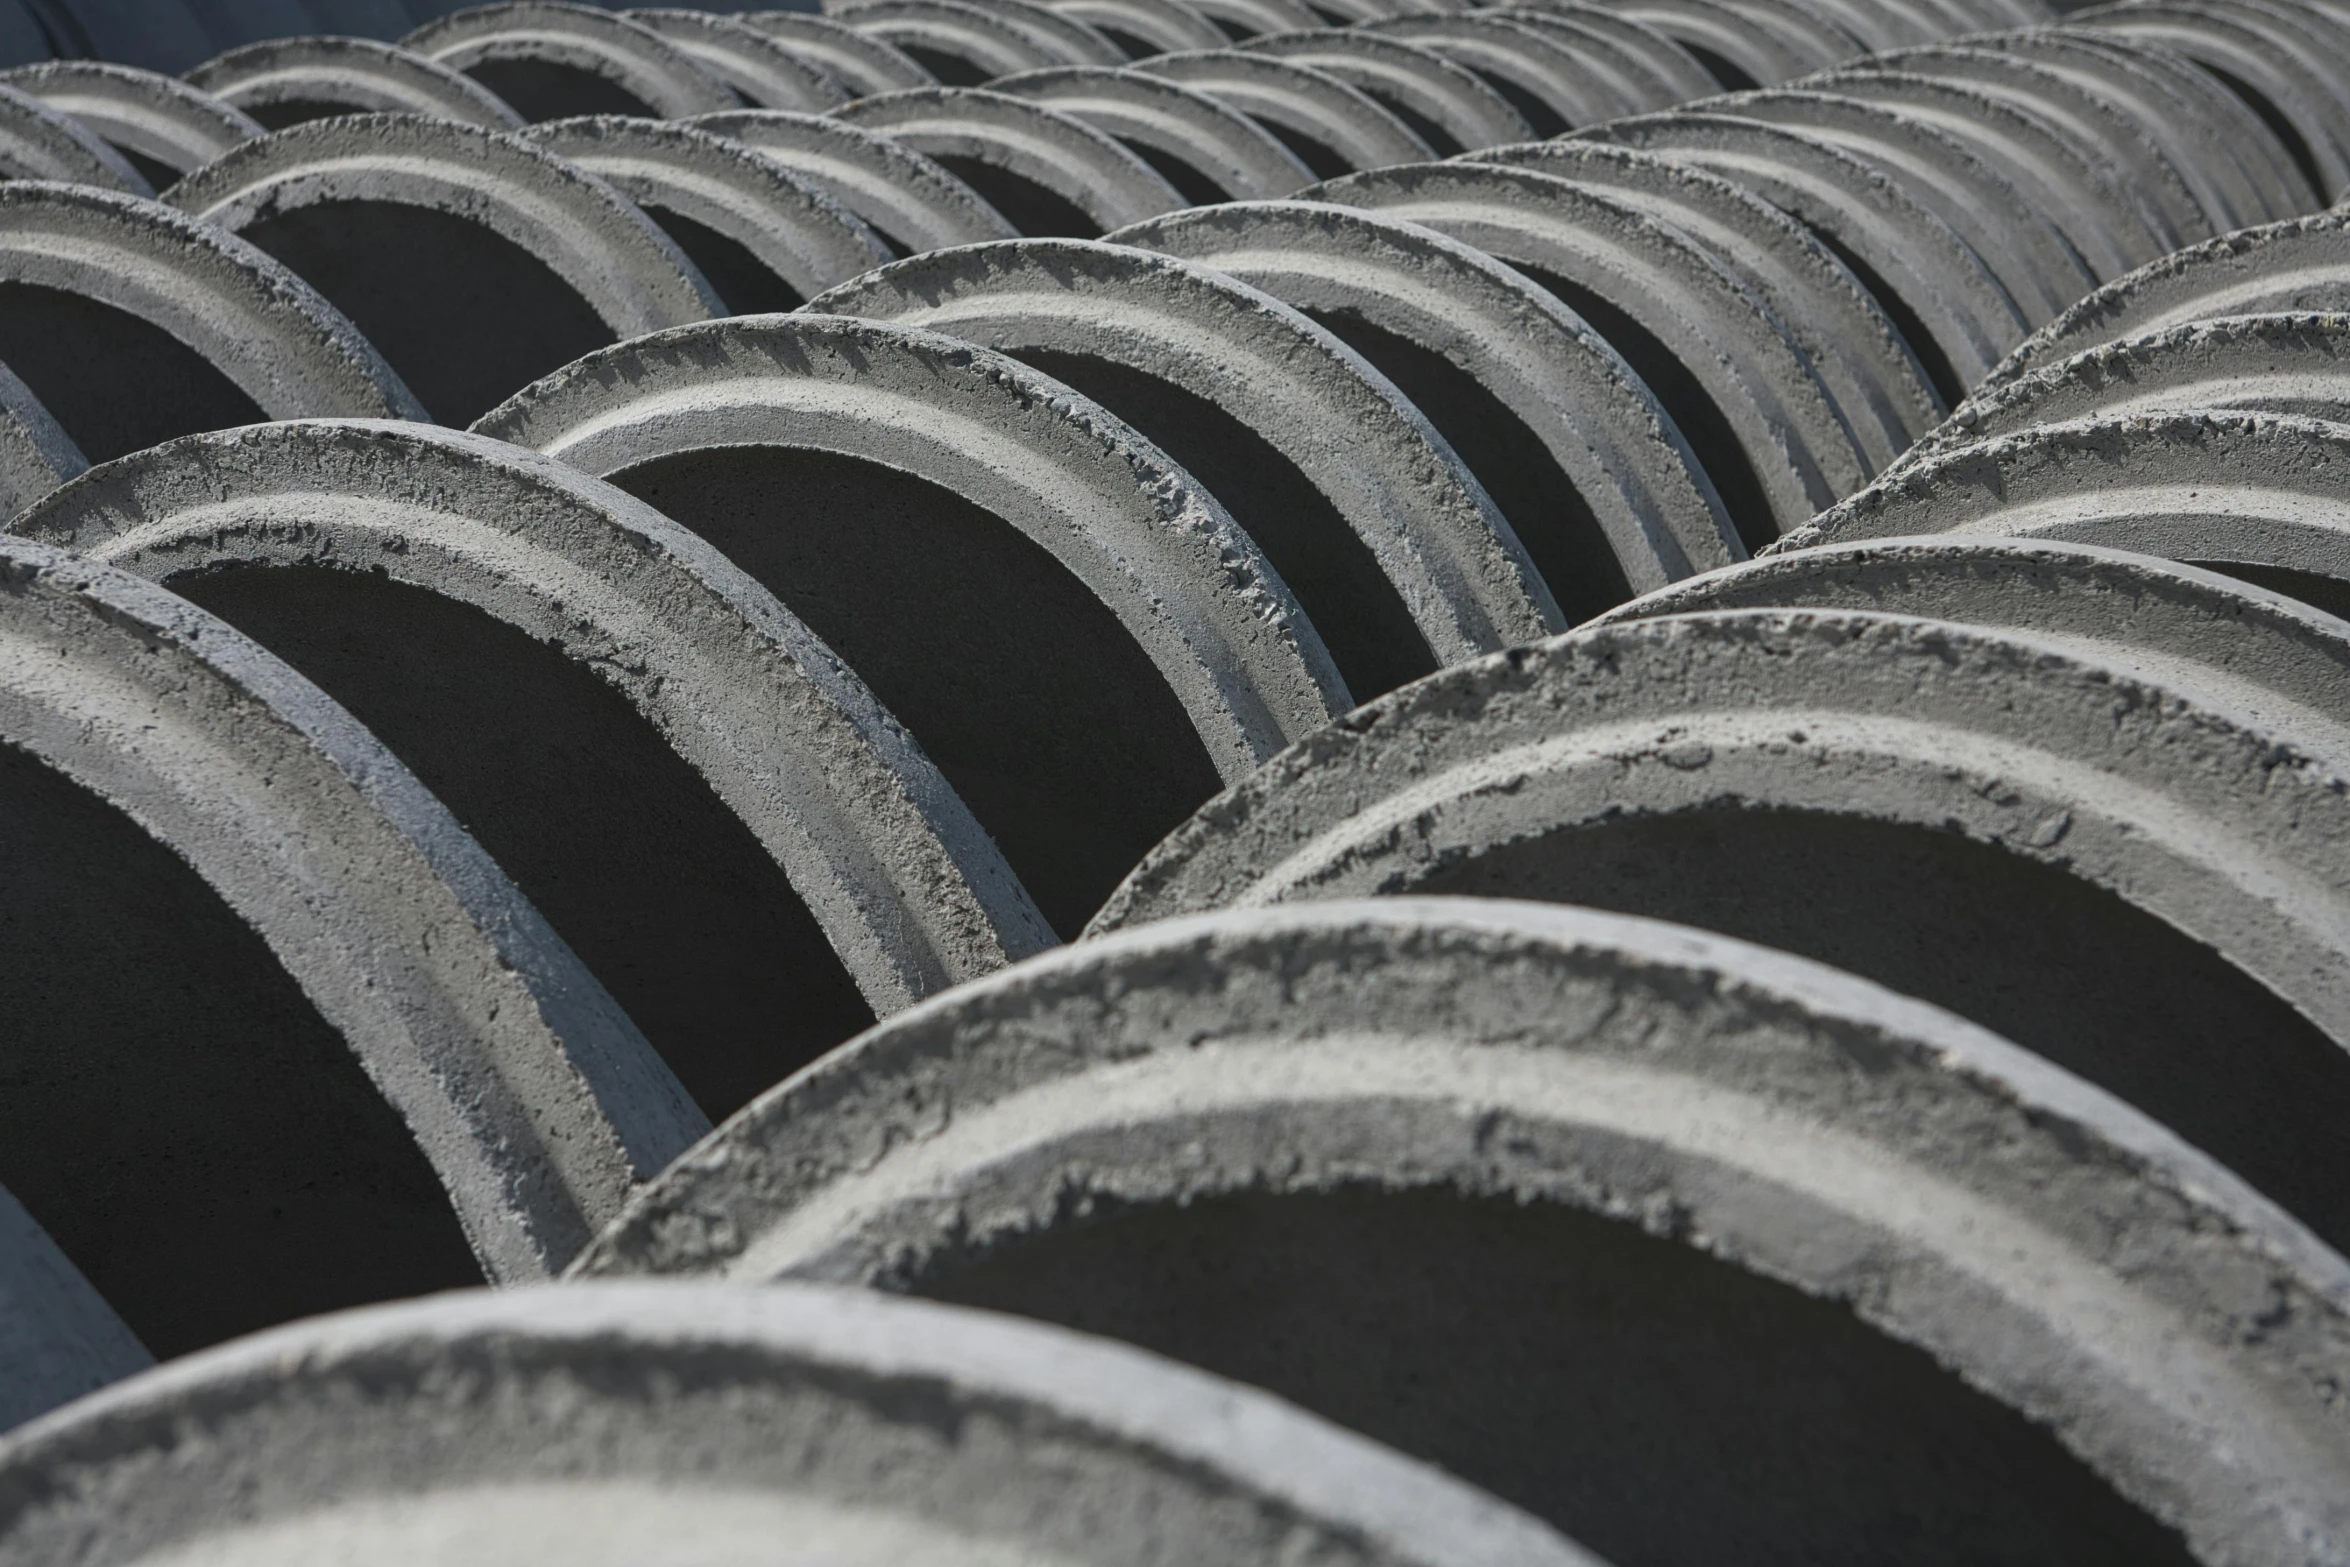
0,747,482,1358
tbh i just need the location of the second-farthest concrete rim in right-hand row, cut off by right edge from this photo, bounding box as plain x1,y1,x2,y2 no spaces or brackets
1901,315,2350,465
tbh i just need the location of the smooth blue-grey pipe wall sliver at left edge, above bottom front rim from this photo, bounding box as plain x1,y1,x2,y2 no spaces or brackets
0,1189,155,1431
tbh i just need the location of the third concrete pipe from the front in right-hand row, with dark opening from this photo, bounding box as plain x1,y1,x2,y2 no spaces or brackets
1093,596,2350,1243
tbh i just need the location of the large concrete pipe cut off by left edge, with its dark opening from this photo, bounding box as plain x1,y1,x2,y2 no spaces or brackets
0,538,707,1356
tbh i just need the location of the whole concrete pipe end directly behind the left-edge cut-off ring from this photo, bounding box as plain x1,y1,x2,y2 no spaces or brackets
14,421,1053,1114
